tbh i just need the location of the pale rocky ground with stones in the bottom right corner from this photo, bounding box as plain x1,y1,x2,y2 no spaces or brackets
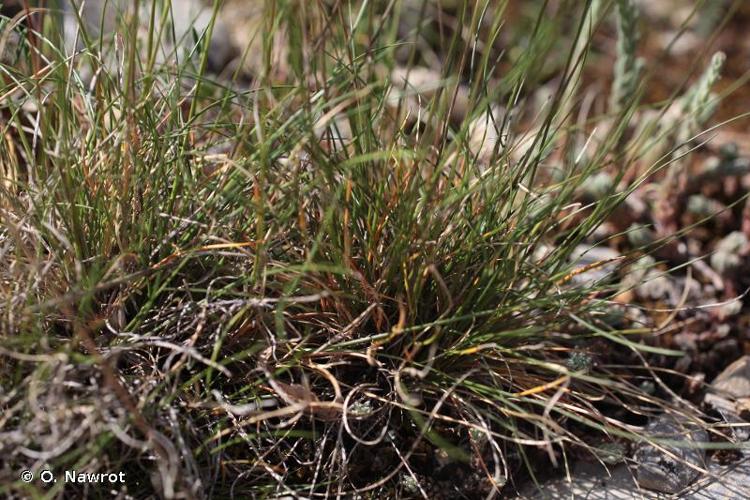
519,356,750,500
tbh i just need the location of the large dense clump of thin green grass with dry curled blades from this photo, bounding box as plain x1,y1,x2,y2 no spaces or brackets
0,1,740,497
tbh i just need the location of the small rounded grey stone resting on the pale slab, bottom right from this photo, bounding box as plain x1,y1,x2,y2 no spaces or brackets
634,415,708,493
